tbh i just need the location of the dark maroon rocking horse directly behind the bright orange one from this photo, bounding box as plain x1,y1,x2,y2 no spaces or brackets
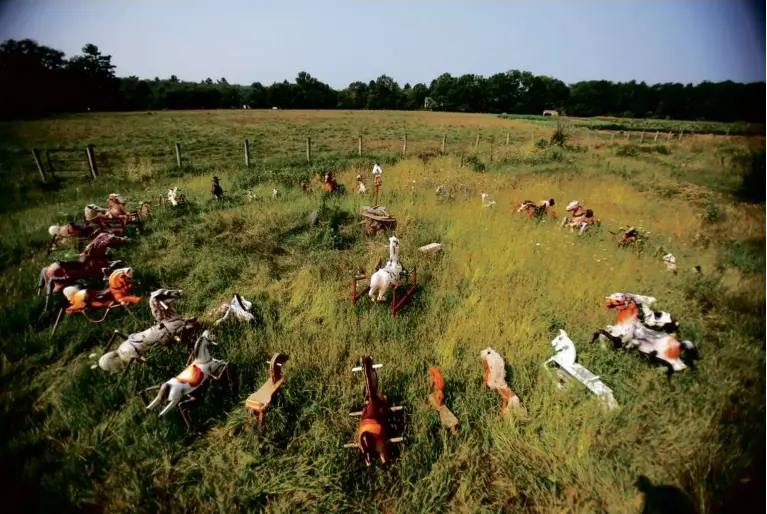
37,233,127,312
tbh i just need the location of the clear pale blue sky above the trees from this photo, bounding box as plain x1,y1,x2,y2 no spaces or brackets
0,0,765,88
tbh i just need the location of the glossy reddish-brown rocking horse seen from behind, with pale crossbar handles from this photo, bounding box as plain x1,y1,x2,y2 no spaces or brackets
344,355,404,466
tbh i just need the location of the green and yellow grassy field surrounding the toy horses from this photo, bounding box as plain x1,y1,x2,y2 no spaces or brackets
0,111,765,513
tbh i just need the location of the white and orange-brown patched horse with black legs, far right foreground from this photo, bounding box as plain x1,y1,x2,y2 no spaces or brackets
592,296,699,378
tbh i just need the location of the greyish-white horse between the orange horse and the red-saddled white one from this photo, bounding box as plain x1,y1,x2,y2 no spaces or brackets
91,289,200,372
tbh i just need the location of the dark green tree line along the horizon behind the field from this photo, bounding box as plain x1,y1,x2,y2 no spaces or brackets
0,39,765,123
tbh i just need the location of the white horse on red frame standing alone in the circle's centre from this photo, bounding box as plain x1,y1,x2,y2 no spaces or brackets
352,236,418,317
